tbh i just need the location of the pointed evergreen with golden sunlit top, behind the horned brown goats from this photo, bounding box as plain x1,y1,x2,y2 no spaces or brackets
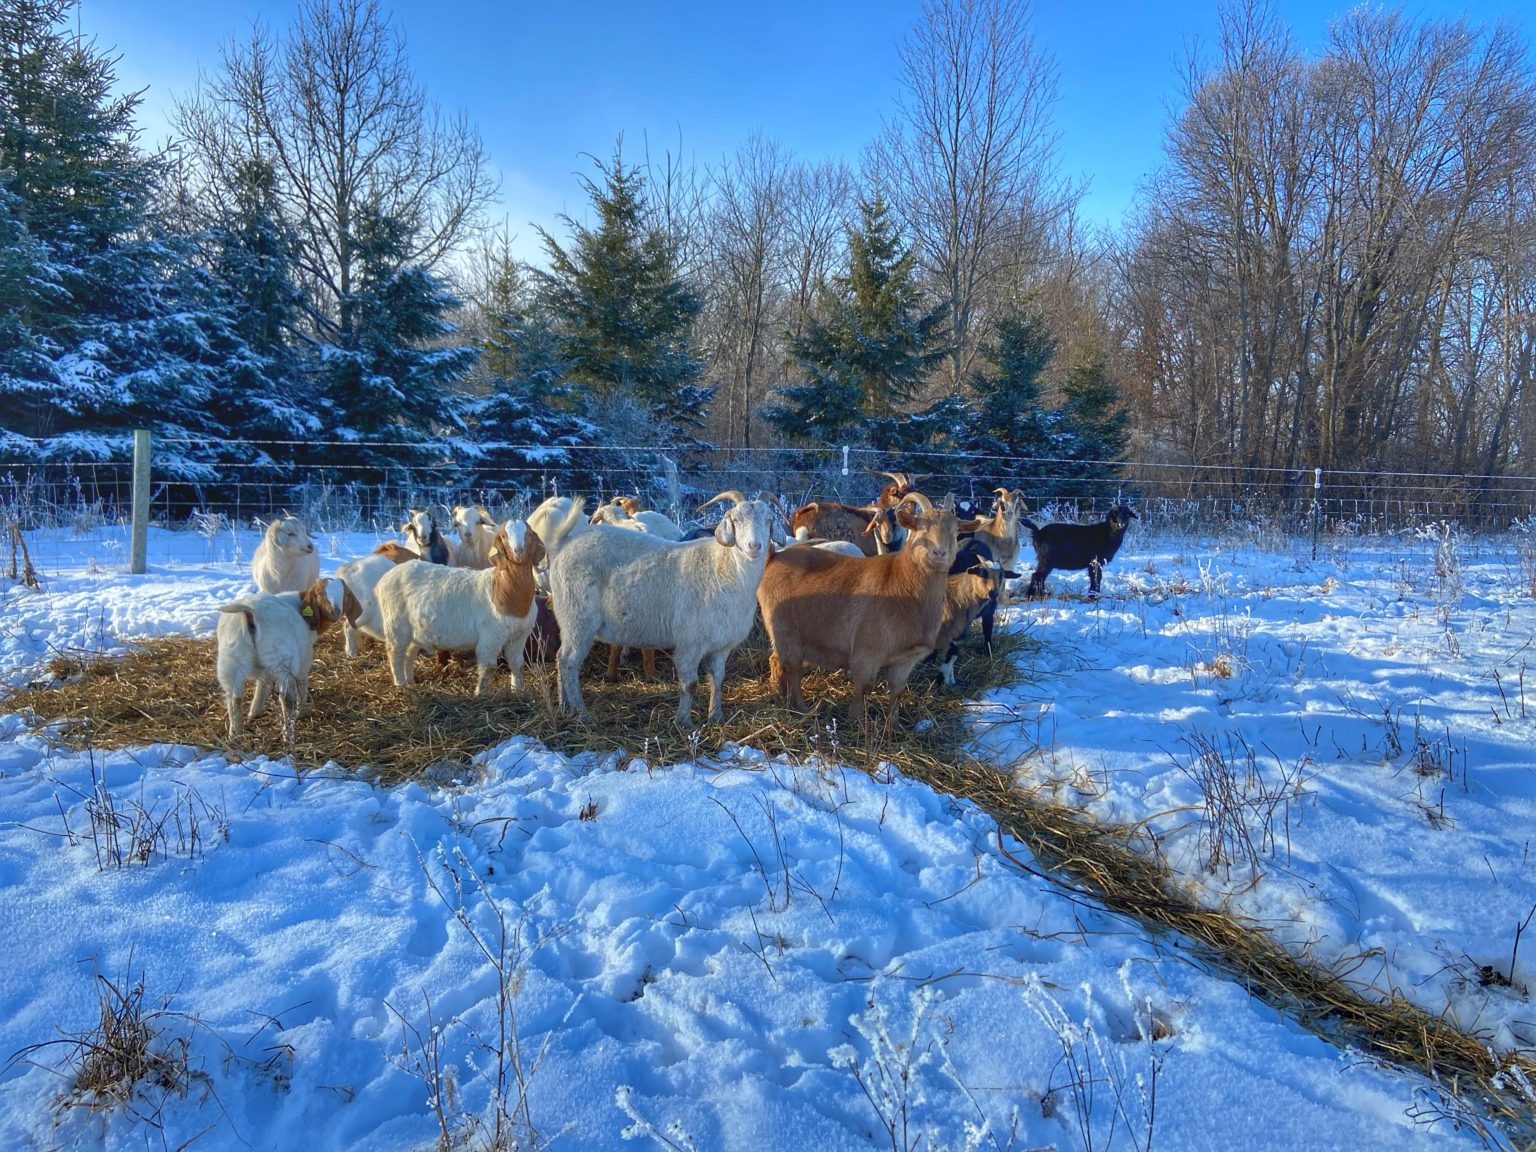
763,192,945,442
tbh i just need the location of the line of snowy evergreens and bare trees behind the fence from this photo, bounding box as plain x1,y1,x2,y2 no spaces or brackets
0,0,1536,513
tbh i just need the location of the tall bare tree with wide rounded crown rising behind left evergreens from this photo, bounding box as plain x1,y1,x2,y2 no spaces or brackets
175,0,495,339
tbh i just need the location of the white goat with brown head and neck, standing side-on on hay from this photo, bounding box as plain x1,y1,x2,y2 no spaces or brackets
375,521,544,696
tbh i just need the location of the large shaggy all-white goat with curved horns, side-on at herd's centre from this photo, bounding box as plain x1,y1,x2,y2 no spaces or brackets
550,492,785,727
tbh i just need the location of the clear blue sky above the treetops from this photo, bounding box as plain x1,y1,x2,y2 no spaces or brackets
80,0,1531,255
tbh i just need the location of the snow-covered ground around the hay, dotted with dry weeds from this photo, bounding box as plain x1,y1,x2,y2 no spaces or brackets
0,528,1536,1152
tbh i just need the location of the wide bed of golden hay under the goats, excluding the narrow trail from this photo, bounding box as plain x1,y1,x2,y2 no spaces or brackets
6,628,1035,783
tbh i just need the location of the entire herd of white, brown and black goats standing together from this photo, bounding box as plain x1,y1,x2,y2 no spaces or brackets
217,473,1135,745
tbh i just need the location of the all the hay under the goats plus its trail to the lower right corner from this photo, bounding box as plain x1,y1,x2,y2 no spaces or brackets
6,630,1536,1143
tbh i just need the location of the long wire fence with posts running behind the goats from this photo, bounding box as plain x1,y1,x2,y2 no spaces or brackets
0,438,1536,546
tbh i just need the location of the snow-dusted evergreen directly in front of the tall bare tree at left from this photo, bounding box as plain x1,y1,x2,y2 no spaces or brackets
319,210,476,468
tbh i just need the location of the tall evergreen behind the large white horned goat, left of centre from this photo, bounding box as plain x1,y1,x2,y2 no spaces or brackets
539,151,714,427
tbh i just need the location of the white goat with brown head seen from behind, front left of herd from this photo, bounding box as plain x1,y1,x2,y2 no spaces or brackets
215,579,347,748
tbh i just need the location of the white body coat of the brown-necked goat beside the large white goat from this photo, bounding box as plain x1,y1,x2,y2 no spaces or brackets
373,540,539,696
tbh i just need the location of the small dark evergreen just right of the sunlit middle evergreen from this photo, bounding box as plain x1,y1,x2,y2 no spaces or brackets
962,312,1060,488
